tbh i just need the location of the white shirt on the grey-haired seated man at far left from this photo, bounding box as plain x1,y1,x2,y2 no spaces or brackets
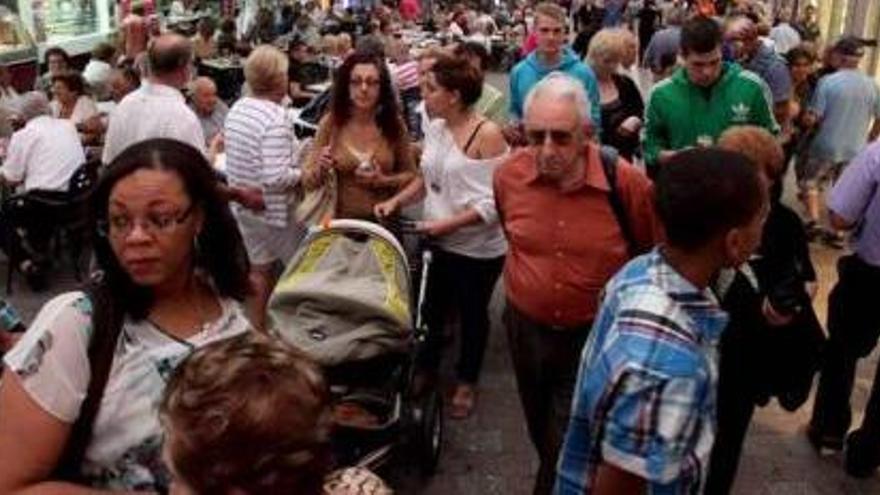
0,115,86,191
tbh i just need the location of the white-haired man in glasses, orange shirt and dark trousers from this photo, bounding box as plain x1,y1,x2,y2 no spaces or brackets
494,73,657,494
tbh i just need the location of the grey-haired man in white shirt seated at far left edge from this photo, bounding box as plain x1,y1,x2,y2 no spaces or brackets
0,91,86,286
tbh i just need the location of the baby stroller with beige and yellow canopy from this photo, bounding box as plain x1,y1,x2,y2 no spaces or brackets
268,220,443,475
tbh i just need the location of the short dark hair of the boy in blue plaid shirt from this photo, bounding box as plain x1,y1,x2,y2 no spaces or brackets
655,148,766,250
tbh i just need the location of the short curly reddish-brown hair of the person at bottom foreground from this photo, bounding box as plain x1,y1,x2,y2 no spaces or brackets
160,332,331,495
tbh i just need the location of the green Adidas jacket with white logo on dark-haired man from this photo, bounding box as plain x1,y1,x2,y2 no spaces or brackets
643,63,779,167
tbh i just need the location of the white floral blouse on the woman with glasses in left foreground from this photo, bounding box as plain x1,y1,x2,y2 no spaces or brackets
4,292,250,492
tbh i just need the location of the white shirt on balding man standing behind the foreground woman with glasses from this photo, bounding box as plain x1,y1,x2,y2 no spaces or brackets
102,82,207,163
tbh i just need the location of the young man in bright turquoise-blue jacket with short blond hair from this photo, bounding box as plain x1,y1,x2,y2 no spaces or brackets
510,2,602,131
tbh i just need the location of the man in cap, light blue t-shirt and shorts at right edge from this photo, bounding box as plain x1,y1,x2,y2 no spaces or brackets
795,36,880,244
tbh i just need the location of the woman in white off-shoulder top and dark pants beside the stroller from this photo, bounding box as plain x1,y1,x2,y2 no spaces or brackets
376,56,508,418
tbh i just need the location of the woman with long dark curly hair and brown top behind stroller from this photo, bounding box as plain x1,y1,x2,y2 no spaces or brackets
302,52,415,220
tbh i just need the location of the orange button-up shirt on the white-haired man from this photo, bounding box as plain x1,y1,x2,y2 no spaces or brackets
494,144,659,328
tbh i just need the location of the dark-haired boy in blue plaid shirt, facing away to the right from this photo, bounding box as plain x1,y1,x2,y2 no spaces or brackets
555,148,769,495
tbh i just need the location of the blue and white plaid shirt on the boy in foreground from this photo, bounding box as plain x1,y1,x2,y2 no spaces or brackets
555,250,727,495
